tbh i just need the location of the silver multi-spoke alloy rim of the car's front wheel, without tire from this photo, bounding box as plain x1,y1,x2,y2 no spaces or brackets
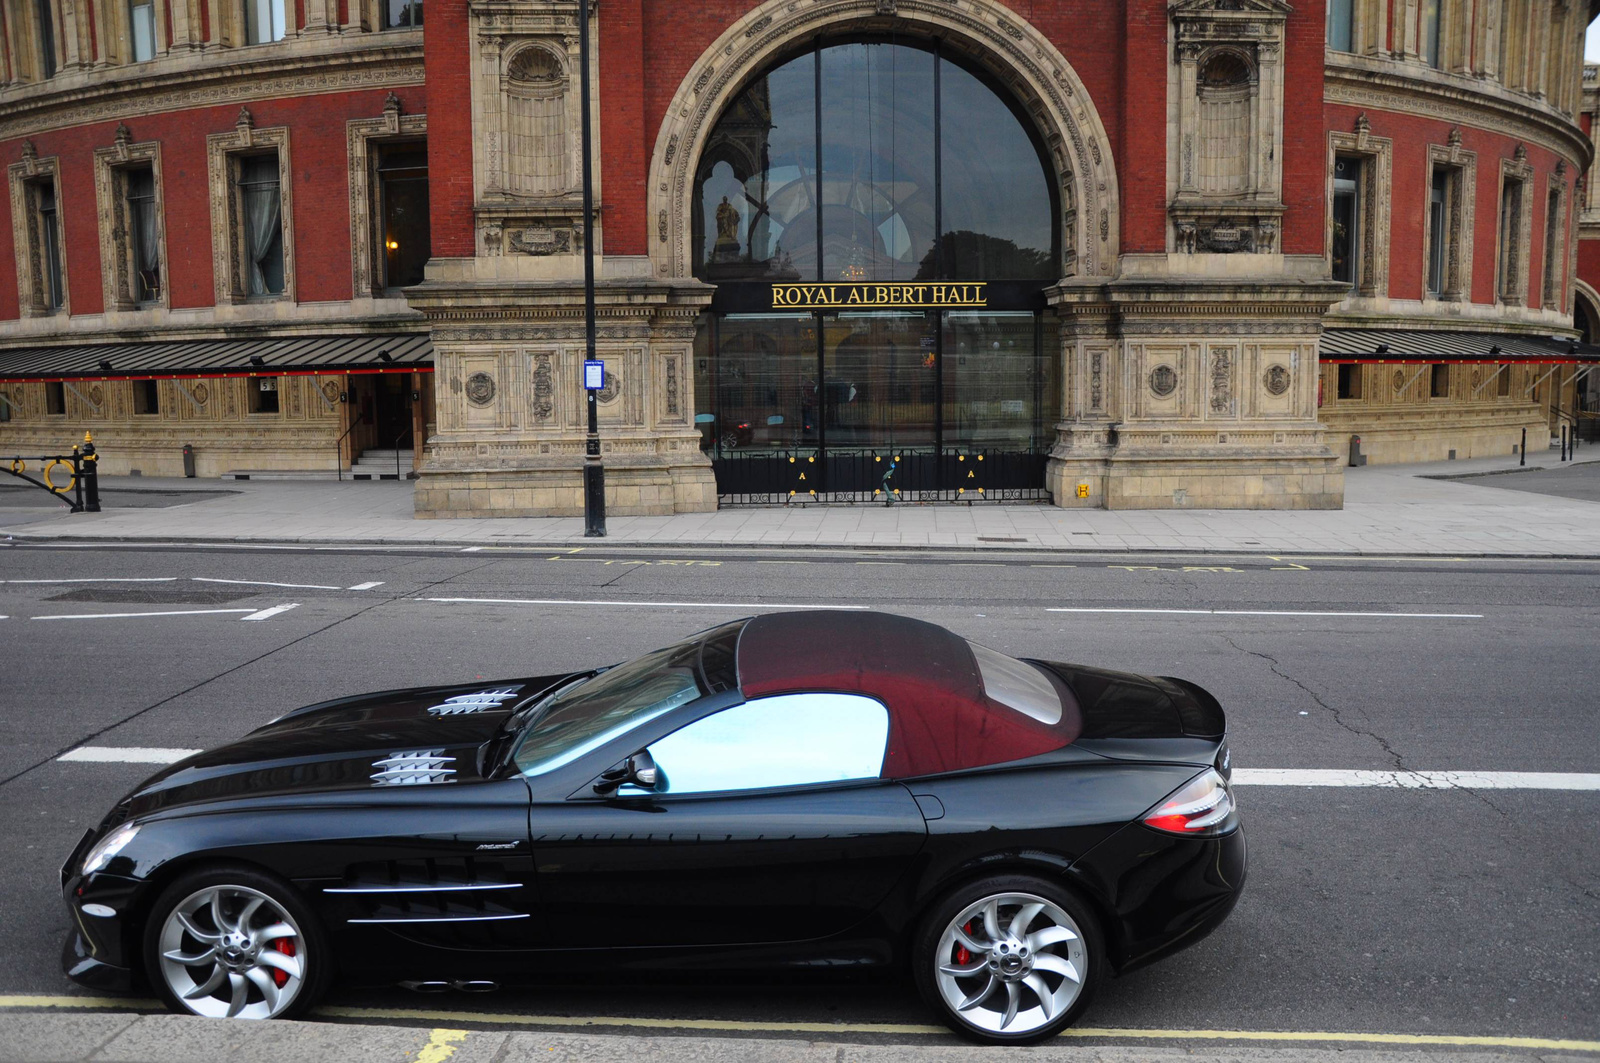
157,885,309,1018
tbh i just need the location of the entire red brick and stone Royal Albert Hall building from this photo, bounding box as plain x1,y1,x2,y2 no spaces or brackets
0,0,1600,517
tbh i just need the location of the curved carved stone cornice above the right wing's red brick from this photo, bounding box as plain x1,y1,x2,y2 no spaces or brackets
1323,53,1594,173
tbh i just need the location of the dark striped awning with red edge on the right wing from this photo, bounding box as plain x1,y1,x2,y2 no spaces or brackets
1322,328,1600,365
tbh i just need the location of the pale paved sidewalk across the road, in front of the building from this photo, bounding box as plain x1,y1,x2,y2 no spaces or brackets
0,451,1600,557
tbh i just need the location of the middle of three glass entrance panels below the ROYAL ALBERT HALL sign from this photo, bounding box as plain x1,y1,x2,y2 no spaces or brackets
822,314,934,453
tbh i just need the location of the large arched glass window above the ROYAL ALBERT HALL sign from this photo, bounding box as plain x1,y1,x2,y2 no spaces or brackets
693,42,1059,283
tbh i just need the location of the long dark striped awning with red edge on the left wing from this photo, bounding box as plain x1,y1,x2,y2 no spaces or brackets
0,333,434,381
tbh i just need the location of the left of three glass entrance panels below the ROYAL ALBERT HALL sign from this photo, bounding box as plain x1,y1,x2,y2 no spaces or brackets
696,314,818,453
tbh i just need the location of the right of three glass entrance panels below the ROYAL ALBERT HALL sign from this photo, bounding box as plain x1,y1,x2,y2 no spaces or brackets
944,312,1059,450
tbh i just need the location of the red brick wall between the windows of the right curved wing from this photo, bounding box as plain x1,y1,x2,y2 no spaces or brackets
1323,104,1576,307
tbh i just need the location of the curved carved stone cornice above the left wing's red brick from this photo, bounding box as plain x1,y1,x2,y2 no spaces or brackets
0,32,422,141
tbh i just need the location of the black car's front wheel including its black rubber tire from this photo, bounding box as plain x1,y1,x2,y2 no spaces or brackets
144,864,333,1018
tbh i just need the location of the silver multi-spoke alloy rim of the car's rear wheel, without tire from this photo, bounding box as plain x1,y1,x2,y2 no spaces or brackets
933,893,1088,1036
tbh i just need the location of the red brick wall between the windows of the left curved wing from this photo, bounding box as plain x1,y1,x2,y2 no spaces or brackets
0,86,425,319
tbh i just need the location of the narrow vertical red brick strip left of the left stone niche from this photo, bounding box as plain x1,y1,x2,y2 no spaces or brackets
422,0,475,258
